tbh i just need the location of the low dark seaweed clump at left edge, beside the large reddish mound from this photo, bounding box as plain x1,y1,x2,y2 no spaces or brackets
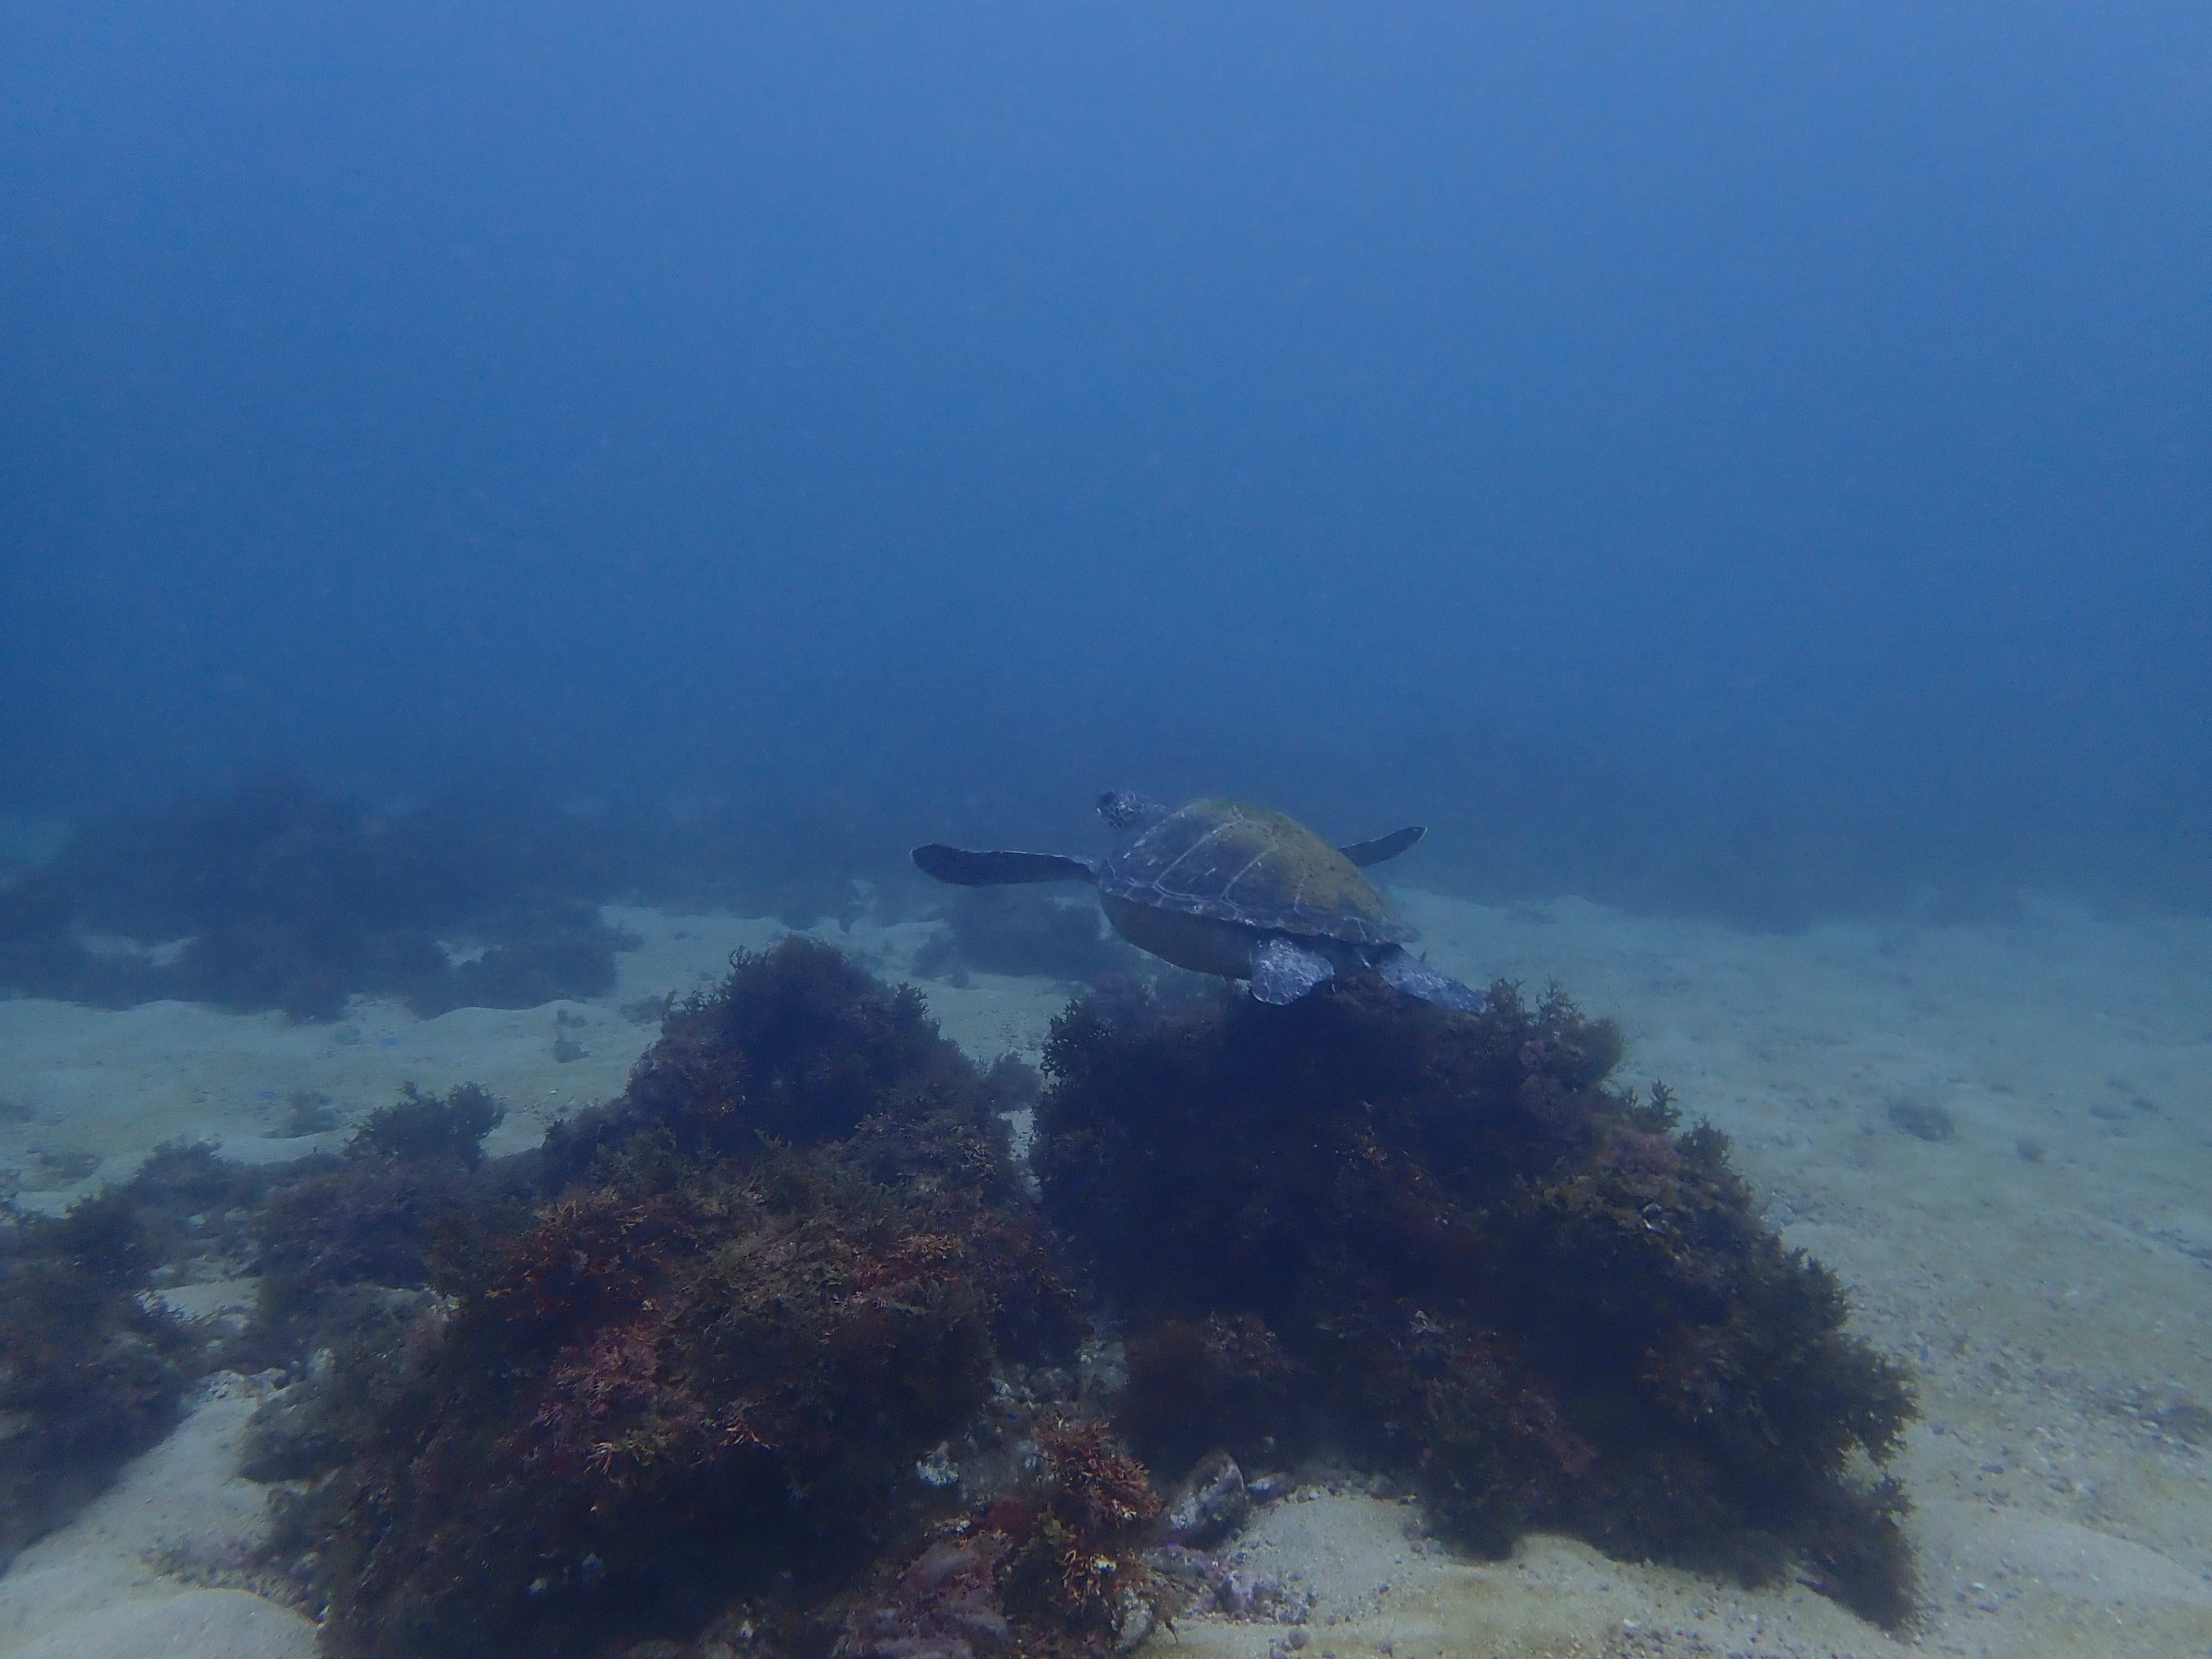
0,1086,513,1562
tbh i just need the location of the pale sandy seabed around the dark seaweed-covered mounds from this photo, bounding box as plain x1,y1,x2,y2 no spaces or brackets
0,889,2212,1659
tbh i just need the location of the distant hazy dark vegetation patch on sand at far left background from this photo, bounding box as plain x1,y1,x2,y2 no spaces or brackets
0,774,630,1018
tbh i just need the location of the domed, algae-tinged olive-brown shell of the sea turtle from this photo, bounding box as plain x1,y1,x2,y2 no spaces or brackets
1099,801,1418,945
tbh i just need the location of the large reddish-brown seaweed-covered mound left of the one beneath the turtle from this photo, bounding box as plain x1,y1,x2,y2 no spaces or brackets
257,940,1075,1655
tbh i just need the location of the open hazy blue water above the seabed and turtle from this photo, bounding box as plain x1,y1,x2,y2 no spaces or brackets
0,0,2212,920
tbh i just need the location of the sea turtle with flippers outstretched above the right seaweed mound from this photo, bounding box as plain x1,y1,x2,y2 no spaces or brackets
914,790,1482,1013
